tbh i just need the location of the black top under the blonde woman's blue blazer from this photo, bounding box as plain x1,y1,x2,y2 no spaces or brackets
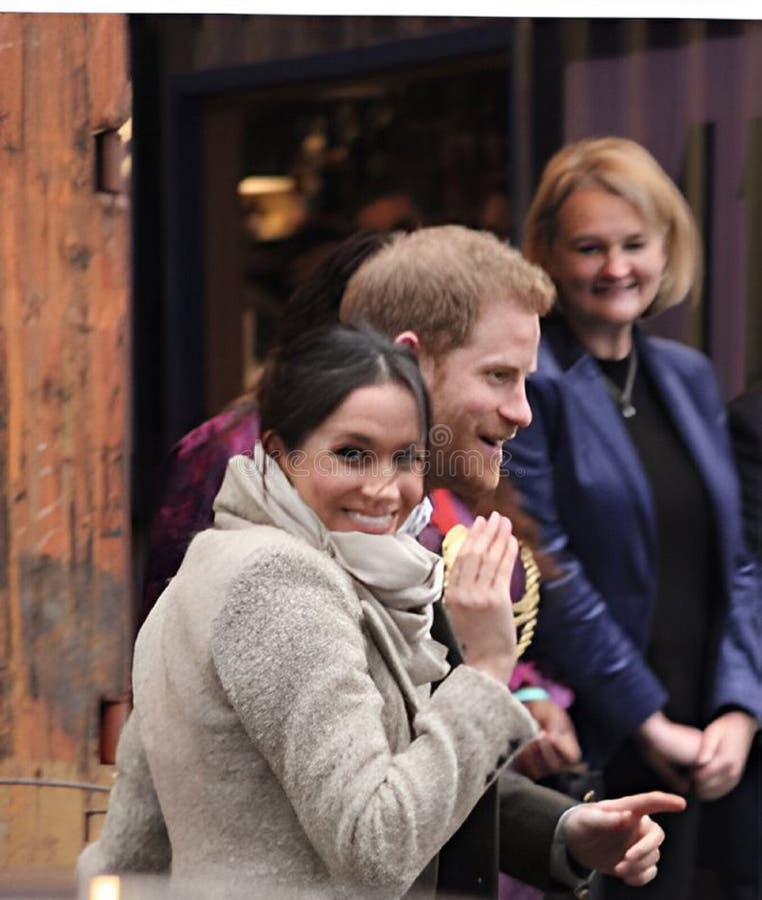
597,357,721,725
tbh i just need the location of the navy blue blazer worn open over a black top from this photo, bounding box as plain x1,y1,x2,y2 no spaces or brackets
504,318,762,765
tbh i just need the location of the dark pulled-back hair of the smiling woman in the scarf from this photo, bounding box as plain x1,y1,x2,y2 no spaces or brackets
257,325,430,451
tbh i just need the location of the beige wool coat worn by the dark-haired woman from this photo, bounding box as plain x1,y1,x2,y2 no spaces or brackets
79,474,536,900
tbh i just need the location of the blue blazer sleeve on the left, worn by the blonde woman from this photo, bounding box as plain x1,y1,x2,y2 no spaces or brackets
505,374,667,748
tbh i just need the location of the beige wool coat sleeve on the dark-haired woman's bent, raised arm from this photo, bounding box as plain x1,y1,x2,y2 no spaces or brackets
212,548,535,895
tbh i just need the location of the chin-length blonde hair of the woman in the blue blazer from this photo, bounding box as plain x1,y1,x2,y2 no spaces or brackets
524,137,701,315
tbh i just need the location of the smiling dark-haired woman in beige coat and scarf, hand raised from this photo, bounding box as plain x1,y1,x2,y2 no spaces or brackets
80,326,535,898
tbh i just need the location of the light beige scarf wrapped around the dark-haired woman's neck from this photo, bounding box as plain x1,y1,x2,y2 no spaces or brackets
214,442,449,686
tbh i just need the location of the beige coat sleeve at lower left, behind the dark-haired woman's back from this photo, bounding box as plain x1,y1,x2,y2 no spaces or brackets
77,711,172,887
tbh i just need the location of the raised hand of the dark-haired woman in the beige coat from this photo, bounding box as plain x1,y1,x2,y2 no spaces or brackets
444,512,519,684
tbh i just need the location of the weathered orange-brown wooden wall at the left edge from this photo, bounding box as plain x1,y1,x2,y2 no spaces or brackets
0,14,132,871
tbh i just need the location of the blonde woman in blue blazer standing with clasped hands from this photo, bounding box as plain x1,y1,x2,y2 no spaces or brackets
506,138,762,900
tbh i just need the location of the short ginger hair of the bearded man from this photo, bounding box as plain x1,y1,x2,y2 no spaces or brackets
341,225,555,354
